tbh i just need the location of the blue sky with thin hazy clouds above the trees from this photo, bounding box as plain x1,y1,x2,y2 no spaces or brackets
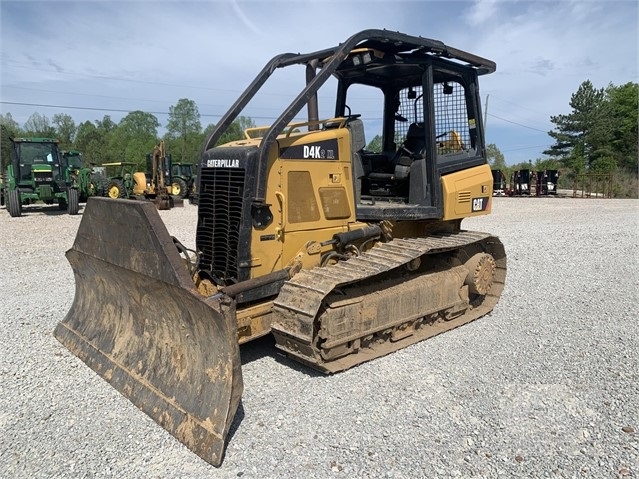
0,0,639,165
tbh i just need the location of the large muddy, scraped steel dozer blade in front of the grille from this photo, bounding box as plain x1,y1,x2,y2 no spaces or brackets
54,197,243,466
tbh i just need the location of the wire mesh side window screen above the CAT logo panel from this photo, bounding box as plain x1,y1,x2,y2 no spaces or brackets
434,82,470,154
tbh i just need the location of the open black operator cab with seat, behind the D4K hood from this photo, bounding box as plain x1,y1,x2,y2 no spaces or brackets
334,41,485,220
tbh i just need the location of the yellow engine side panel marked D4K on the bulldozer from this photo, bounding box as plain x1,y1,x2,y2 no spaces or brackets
251,124,363,278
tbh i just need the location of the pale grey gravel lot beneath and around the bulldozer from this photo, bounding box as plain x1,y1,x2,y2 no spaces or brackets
0,198,639,478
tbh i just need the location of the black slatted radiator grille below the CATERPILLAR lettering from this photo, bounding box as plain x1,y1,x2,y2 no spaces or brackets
196,168,245,285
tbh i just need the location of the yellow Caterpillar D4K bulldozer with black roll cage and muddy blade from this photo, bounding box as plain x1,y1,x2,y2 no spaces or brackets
55,30,507,466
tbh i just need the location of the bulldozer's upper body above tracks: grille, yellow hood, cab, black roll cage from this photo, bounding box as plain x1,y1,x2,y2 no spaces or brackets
196,30,496,270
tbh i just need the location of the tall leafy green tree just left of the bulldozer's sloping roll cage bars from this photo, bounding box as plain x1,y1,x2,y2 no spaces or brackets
165,98,202,161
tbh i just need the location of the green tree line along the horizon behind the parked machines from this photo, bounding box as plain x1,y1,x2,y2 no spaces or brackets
0,80,639,197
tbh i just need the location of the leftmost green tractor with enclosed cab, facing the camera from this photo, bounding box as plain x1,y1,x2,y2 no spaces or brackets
1,138,80,217
